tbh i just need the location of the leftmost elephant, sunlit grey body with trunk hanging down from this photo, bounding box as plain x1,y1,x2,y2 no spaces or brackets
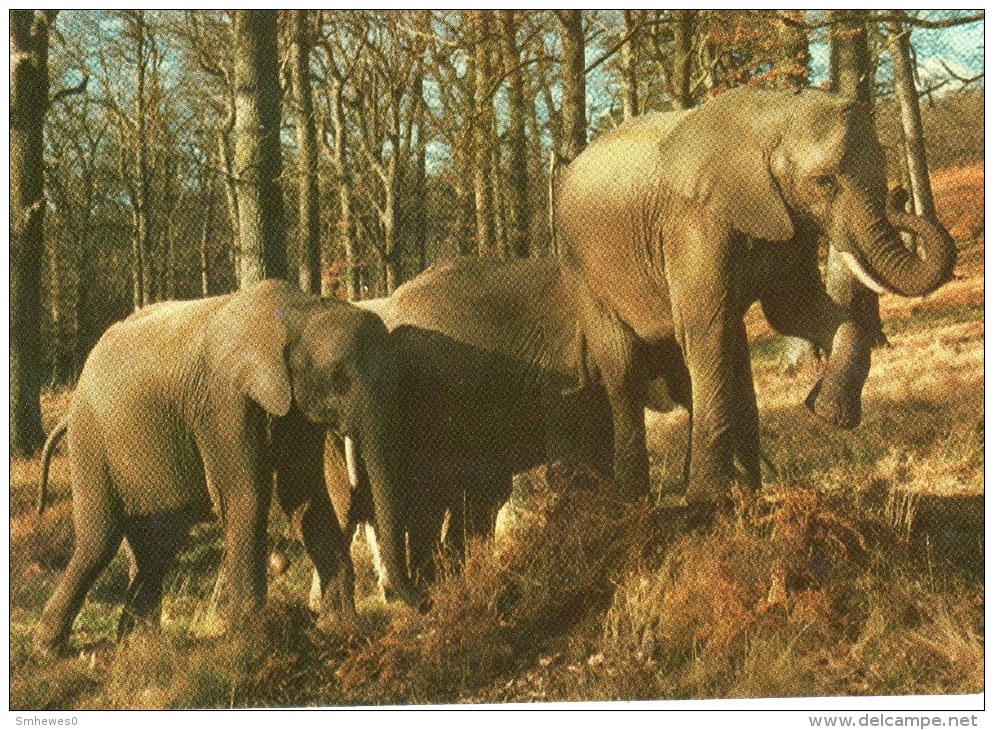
35,281,415,653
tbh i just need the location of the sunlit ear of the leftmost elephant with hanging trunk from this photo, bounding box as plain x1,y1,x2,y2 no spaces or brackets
205,280,294,416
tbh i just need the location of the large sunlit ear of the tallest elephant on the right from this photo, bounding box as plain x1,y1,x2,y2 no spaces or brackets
660,89,794,241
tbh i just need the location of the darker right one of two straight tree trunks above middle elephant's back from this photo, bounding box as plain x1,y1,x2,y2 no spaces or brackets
498,10,531,259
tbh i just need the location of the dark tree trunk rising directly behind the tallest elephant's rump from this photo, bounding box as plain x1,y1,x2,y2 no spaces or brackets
555,10,587,164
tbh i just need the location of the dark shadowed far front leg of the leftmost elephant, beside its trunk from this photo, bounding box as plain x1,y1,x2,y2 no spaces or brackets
272,409,355,620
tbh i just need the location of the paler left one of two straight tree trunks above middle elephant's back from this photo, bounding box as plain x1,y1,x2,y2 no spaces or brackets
470,10,494,256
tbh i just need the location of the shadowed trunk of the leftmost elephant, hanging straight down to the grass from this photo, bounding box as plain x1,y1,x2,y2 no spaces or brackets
359,390,422,606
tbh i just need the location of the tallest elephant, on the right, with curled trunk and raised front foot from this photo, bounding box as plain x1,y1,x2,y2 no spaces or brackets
556,88,956,504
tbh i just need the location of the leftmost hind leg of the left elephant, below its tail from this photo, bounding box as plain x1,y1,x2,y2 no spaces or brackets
34,456,123,654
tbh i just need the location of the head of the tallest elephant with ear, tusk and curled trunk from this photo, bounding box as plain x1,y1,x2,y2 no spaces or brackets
661,89,956,296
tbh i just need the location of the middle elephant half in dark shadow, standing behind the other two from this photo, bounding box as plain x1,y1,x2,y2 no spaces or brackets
326,257,690,586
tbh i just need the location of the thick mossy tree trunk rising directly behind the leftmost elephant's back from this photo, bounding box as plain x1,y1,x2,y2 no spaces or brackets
234,10,287,288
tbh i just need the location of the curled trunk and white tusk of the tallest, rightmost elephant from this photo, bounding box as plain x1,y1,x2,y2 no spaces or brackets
843,195,956,297
